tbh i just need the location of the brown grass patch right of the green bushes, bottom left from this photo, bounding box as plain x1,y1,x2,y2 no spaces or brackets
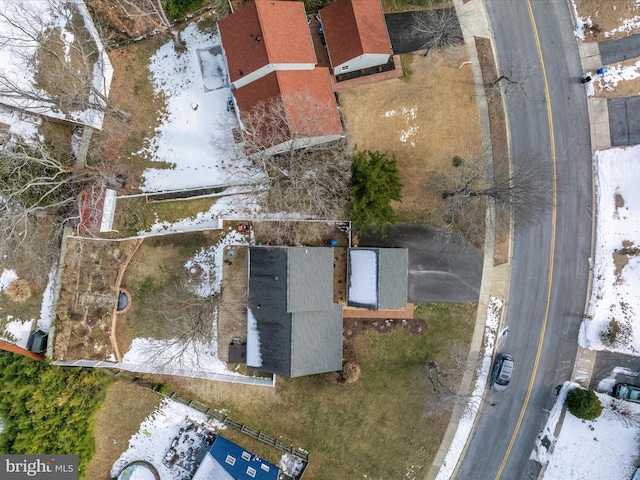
85,381,161,480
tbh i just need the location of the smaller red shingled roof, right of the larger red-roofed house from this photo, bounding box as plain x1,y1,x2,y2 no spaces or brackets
320,0,392,68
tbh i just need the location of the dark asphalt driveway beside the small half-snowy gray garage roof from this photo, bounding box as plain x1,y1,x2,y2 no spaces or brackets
360,223,482,303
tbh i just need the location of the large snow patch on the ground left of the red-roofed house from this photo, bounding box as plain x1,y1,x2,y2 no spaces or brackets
139,23,255,192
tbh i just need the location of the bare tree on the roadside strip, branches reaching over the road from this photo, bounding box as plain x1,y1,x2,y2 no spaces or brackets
439,157,552,242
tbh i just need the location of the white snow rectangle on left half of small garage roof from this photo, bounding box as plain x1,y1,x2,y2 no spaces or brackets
348,249,378,308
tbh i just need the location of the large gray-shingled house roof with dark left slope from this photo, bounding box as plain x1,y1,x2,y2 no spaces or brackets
247,246,342,377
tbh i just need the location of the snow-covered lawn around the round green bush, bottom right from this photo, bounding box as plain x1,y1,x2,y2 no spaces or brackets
533,383,640,480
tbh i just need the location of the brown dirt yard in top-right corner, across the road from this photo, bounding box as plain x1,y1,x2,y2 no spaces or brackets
575,0,640,42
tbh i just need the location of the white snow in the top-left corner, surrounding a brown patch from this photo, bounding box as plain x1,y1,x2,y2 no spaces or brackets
0,0,113,129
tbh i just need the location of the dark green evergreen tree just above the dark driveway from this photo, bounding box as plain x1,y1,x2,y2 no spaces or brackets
349,150,402,233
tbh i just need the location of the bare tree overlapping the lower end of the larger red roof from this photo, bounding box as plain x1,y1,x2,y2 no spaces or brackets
230,95,351,227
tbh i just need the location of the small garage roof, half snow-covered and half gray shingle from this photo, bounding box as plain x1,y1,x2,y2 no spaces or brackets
347,247,409,310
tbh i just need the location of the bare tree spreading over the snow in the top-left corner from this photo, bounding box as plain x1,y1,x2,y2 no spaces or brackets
0,0,131,121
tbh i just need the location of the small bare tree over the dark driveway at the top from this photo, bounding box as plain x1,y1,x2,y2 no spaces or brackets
411,8,463,57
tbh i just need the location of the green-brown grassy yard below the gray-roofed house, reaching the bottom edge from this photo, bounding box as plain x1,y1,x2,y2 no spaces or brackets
156,305,476,479
